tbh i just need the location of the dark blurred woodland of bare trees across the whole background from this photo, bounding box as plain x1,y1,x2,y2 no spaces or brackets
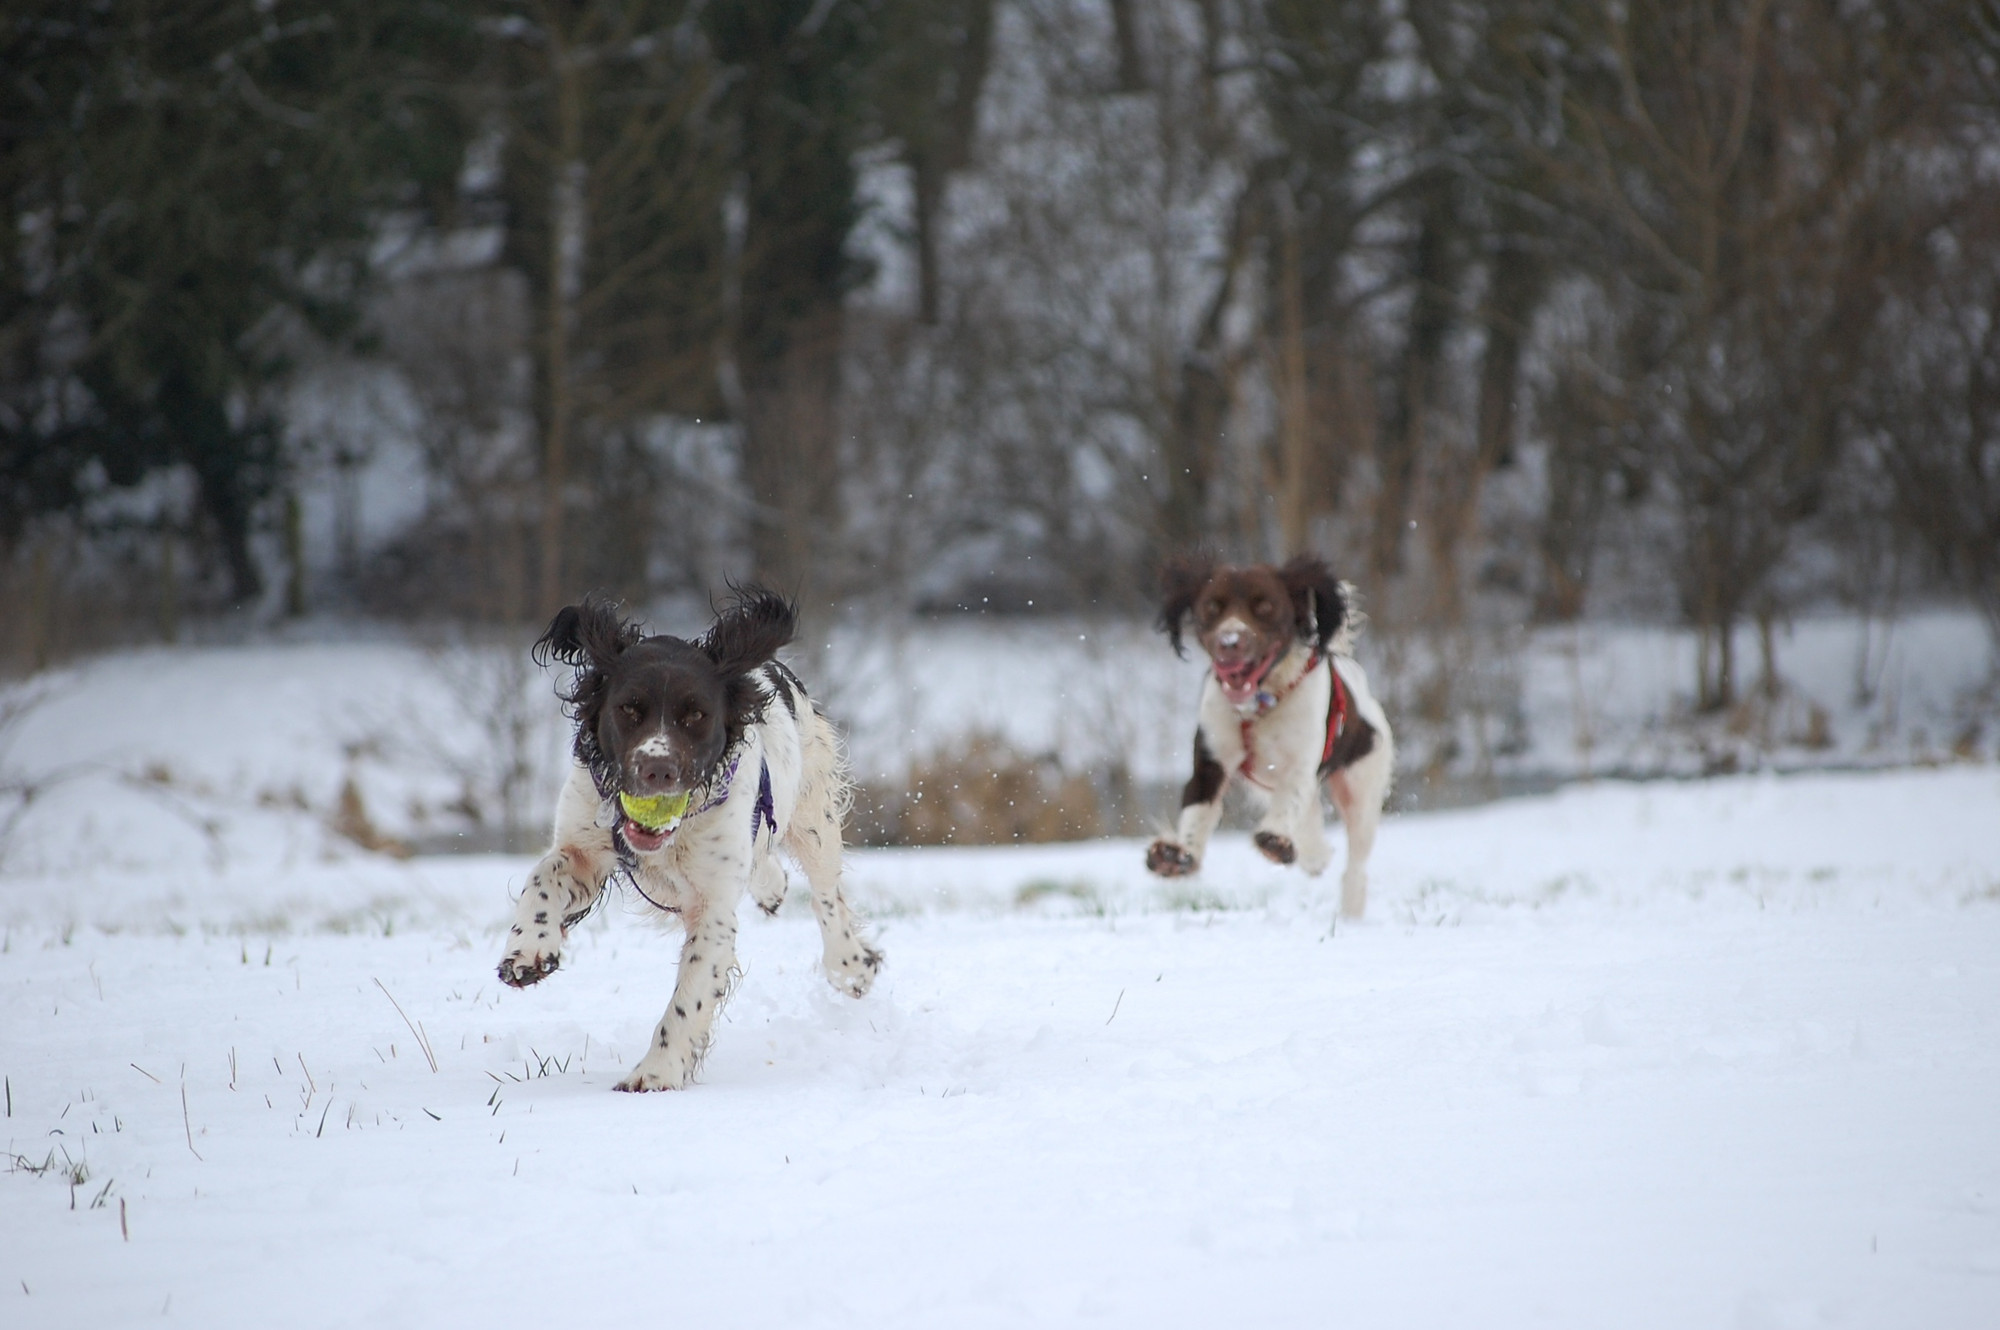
0,0,2000,728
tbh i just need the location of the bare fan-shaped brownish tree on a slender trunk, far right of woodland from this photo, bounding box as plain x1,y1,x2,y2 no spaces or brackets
1500,0,1940,710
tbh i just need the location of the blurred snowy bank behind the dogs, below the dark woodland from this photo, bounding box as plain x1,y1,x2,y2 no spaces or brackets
0,614,2000,876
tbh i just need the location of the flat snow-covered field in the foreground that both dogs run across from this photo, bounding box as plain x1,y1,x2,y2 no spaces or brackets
0,764,2000,1328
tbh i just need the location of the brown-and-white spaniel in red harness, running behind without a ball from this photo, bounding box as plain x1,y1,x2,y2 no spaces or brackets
1146,556,1396,918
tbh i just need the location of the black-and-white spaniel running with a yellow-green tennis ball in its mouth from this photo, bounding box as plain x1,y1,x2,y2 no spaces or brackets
500,588,882,1090
